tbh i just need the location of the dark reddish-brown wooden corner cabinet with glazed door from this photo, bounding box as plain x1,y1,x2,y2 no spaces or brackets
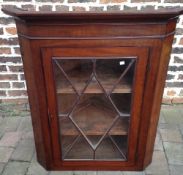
3,8,183,170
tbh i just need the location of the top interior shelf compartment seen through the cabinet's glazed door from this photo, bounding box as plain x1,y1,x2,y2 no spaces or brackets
53,60,134,94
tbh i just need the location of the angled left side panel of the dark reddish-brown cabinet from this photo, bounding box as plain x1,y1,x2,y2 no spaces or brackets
19,36,51,168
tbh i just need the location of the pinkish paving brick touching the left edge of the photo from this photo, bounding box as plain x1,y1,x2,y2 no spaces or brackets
0,132,22,147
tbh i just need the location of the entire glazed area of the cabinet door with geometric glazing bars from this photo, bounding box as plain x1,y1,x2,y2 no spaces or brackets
53,58,135,161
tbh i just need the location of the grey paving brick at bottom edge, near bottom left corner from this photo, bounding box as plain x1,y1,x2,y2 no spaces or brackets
2,162,29,175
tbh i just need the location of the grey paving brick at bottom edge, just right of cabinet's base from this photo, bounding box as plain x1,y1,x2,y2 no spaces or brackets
145,151,169,175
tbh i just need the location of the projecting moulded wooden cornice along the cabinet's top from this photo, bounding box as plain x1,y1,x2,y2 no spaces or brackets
2,7,183,22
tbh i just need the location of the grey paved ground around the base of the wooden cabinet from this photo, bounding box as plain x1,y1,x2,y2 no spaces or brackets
0,106,183,175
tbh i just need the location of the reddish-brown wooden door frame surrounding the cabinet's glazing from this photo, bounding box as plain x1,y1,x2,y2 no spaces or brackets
41,46,149,169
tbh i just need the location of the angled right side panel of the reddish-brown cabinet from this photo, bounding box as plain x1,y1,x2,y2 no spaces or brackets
144,36,174,166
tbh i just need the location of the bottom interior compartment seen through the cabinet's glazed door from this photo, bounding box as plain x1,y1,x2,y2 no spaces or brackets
61,136,127,160
